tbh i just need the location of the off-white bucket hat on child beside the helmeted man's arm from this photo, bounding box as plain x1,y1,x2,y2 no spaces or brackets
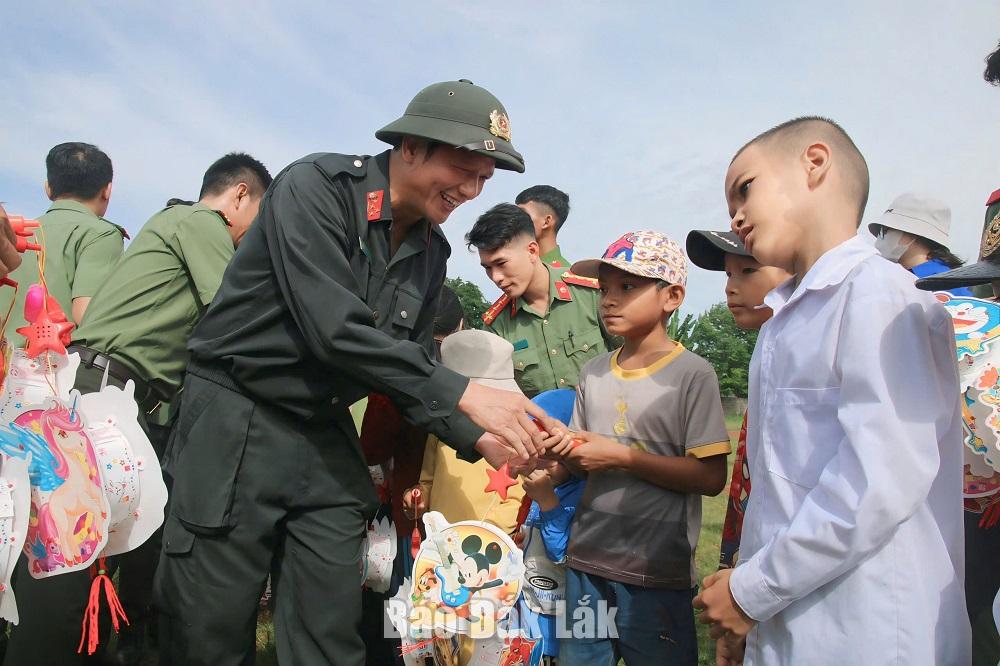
441,329,521,393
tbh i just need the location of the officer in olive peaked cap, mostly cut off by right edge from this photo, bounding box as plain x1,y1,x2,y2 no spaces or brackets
916,184,1000,666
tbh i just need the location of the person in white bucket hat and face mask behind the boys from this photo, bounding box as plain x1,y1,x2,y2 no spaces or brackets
868,193,972,296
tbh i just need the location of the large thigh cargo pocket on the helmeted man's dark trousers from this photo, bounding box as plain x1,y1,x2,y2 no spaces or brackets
170,385,254,534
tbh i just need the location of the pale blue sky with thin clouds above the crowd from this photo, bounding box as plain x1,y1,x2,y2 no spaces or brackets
0,0,1000,312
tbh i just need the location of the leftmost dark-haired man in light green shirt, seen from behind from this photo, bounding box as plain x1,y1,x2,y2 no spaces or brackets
0,142,128,338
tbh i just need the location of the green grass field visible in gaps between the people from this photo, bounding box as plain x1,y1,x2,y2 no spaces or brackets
257,418,740,666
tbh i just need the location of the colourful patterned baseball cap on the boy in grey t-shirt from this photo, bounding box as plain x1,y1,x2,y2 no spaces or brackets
570,231,687,286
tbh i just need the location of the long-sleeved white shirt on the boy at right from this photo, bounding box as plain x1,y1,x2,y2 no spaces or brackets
730,237,971,666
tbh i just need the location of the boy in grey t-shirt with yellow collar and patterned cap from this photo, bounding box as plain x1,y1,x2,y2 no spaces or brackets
550,231,731,666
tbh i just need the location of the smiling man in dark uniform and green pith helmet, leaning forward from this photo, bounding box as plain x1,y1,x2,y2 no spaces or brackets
155,80,558,666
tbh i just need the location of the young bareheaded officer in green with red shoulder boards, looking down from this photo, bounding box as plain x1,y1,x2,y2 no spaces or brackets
465,204,617,397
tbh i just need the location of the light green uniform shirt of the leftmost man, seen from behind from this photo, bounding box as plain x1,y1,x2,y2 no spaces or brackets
0,199,128,347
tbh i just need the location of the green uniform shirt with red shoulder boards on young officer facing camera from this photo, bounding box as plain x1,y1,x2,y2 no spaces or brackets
483,266,617,397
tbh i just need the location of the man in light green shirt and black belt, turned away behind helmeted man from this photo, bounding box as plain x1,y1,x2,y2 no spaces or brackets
4,153,271,666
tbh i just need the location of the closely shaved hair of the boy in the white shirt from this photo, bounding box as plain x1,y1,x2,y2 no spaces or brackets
730,116,869,227
